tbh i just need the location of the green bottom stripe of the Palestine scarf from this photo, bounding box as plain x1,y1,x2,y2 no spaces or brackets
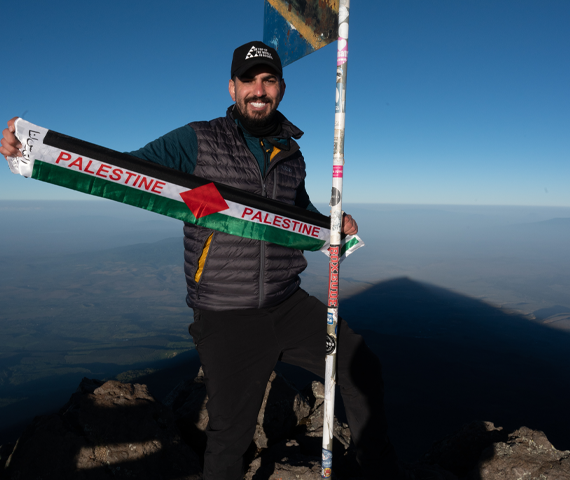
32,159,324,251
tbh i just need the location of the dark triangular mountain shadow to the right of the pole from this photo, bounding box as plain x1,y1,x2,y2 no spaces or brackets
340,278,570,460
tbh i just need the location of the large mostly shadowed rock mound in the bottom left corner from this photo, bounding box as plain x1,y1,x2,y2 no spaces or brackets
3,379,201,480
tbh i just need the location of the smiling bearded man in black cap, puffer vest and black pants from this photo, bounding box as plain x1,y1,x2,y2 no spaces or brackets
0,42,398,480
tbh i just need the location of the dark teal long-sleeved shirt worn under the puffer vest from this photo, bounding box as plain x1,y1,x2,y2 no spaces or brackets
129,125,320,213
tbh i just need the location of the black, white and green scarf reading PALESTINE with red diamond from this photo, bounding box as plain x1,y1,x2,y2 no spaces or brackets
8,118,364,257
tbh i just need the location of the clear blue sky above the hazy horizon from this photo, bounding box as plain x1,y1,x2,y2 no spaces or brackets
0,0,570,206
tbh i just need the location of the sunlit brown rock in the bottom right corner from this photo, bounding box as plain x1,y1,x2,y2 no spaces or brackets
468,427,570,480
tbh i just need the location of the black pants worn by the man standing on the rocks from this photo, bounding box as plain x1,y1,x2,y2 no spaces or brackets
190,290,397,480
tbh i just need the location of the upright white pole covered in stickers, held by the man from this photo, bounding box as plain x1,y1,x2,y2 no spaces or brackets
321,0,350,478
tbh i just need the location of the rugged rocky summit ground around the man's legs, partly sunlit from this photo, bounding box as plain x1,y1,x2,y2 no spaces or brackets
0,371,570,480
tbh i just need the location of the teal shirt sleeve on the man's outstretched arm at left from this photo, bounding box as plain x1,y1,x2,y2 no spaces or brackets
128,125,198,174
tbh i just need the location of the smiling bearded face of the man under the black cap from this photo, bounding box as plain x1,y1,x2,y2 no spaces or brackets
229,65,285,125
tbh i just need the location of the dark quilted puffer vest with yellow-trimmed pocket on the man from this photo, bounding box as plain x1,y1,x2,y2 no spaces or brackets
184,106,307,310
